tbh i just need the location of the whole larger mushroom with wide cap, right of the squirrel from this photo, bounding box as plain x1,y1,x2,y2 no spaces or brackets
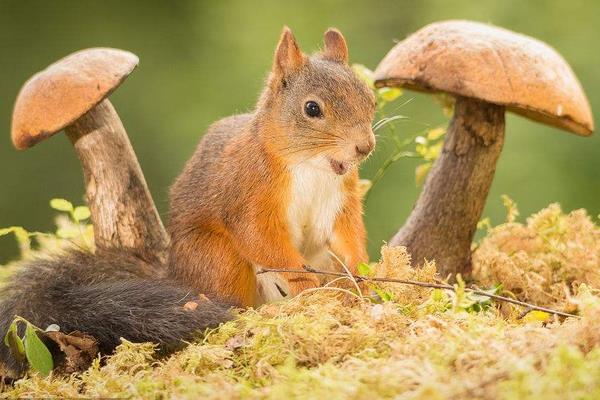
375,21,594,276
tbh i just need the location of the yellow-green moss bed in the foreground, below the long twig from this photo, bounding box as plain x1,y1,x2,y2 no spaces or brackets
6,286,600,399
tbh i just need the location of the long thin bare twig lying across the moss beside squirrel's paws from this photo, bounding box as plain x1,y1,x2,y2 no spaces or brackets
256,266,581,318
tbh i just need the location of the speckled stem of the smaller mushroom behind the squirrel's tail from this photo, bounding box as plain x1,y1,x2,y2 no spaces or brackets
66,99,169,263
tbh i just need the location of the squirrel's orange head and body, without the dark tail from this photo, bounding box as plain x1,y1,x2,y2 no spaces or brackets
168,28,375,306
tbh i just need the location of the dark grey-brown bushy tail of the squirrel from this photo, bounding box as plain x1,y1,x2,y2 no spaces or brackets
0,251,231,374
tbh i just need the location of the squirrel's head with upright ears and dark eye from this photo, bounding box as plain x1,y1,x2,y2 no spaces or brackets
258,27,375,175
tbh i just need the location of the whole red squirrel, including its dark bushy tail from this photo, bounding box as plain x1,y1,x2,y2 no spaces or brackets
0,28,375,376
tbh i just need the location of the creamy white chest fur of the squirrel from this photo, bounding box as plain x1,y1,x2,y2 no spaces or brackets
287,159,344,267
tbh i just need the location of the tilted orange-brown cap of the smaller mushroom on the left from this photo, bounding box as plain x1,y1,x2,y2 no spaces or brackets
11,48,139,149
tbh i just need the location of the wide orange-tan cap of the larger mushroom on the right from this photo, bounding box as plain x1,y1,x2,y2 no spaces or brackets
375,21,594,136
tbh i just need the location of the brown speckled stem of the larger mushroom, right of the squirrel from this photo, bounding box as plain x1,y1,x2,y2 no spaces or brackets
390,97,504,277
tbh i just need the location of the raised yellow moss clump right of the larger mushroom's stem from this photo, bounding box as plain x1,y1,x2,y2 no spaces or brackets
473,204,600,309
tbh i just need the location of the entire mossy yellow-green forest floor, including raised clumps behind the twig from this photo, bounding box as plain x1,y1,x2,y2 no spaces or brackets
0,204,600,399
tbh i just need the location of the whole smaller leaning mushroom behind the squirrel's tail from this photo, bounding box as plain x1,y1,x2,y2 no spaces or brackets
12,48,168,263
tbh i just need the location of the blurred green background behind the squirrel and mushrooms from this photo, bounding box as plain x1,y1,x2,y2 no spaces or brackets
0,0,600,264
